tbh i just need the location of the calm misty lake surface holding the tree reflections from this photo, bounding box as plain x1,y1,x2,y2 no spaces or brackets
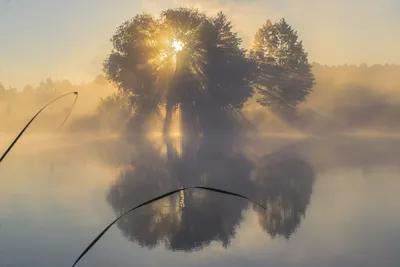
0,135,400,267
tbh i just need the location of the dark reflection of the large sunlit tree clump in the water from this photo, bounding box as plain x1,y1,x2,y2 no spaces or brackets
108,133,252,251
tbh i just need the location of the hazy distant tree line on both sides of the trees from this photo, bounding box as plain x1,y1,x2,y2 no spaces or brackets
0,63,400,132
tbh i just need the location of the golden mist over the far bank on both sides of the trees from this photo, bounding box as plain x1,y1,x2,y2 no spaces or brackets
0,56,400,140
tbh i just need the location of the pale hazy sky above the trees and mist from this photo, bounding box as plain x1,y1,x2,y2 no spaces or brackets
0,0,400,87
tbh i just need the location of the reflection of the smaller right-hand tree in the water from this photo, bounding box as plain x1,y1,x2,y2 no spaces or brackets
256,153,315,239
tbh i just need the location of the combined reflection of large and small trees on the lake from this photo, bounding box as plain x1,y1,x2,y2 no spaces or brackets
108,130,315,252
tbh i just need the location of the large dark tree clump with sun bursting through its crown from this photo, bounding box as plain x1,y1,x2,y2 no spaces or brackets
104,8,252,132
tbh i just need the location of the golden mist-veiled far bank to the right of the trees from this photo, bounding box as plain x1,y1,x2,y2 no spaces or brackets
239,63,400,136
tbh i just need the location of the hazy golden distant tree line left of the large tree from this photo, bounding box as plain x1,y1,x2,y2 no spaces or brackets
0,75,116,133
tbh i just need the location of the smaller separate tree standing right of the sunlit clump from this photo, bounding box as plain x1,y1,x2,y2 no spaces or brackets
250,19,314,120
